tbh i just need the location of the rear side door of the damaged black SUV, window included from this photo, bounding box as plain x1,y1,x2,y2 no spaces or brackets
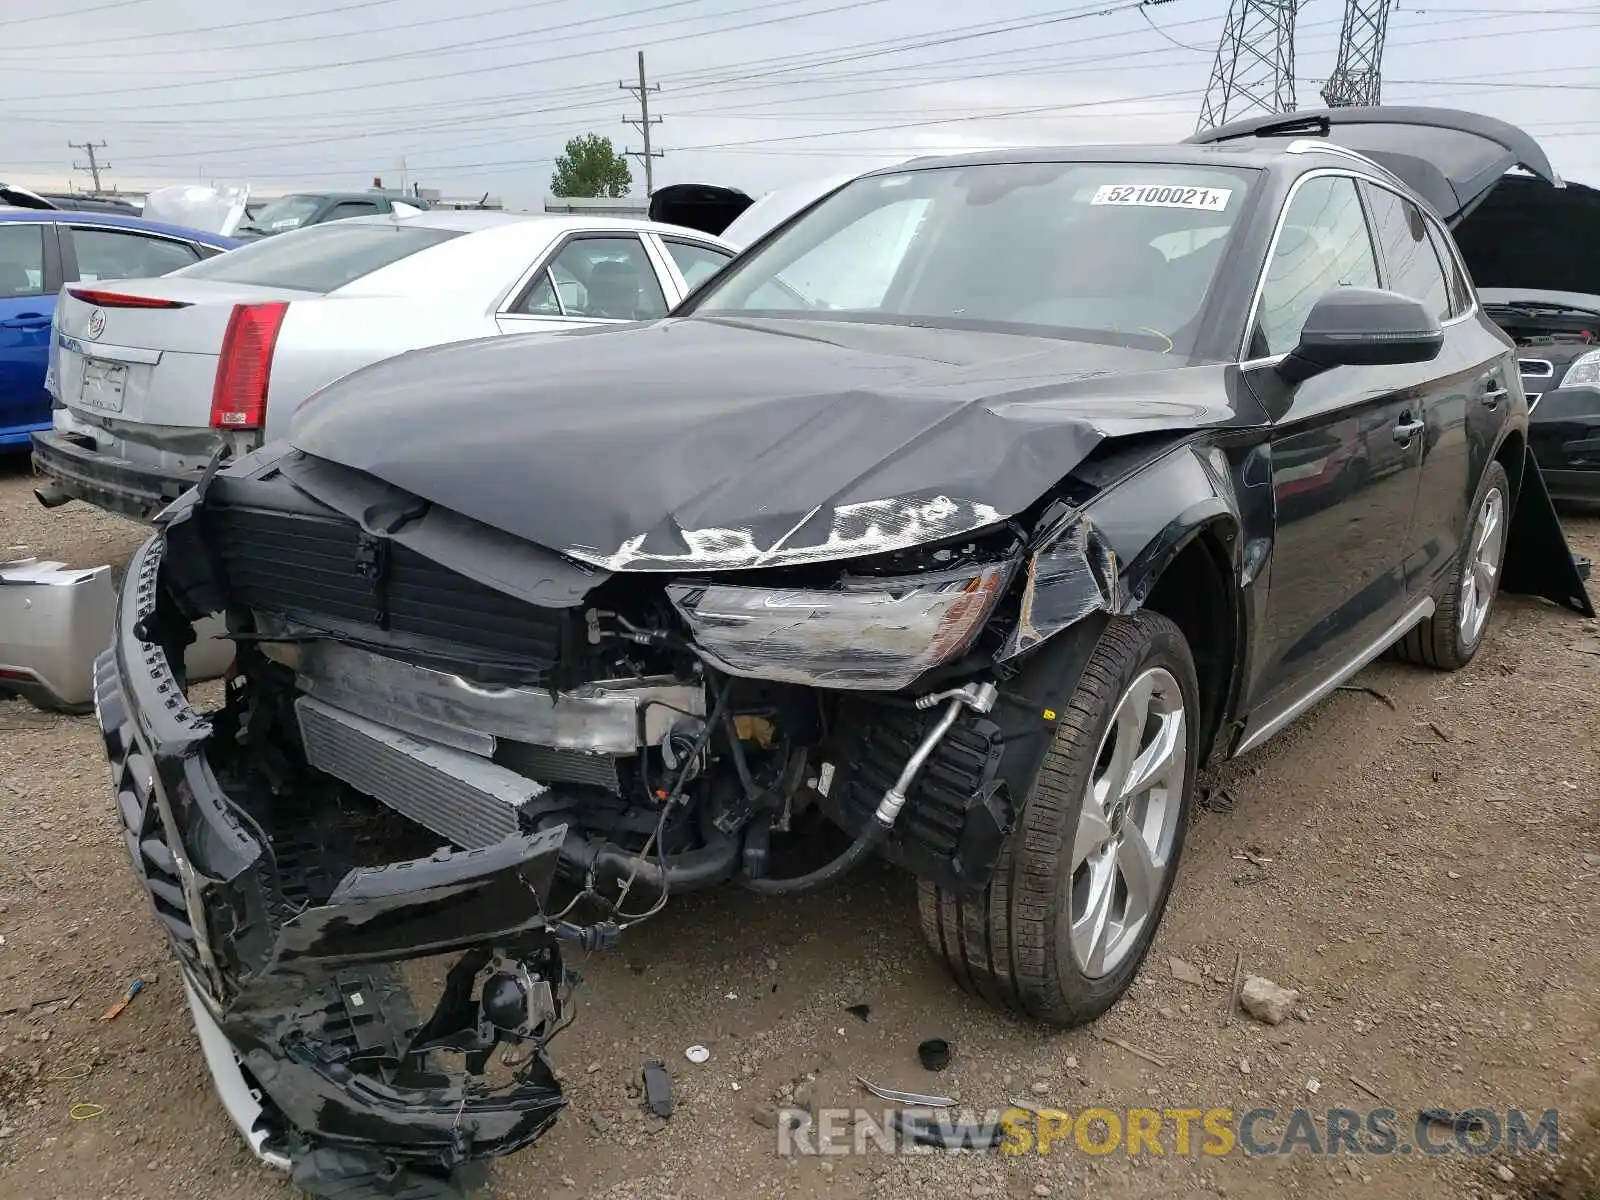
1362,182,1518,595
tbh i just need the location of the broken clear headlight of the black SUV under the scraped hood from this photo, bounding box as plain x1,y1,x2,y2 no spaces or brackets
667,565,1011,691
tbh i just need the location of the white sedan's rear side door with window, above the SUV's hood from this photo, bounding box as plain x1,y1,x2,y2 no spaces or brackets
496,230,678,333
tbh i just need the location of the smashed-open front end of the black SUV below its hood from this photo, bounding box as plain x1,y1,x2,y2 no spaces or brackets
116,448,1075,1194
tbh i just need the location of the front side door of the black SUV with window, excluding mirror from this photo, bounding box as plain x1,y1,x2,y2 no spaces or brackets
1253,171,1427,709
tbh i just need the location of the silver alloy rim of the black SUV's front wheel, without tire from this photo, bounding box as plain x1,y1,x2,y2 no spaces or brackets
1069,667,1189,979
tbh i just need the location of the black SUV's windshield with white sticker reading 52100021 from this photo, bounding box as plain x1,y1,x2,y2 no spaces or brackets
693,163,1256,354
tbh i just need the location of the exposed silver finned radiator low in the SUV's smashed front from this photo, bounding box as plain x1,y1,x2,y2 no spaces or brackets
294,696,547,850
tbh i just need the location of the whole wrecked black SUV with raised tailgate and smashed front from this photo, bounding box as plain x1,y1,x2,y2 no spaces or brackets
96,109,1592,1195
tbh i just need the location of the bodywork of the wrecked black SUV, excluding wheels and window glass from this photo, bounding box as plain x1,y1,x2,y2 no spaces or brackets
98,115,1594,1192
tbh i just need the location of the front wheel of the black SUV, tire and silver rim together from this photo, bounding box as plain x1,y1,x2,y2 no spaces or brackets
918,613,1200,1027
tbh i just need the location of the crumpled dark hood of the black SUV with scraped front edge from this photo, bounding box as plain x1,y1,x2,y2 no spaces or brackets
290,317,1235,571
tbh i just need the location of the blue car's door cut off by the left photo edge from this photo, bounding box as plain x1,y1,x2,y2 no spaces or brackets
0,221,61,445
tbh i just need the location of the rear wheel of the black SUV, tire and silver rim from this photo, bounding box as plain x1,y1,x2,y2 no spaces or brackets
1394,462,1512,670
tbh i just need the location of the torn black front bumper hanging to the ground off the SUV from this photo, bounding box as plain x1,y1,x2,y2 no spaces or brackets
94,541,568,1190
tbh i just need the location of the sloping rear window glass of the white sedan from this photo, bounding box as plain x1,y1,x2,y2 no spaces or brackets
172,221,461,293
